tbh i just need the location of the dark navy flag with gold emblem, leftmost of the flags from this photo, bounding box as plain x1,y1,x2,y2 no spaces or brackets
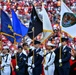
0,10,14,43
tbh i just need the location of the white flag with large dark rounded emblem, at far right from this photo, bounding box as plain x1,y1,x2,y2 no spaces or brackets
60,2,76,37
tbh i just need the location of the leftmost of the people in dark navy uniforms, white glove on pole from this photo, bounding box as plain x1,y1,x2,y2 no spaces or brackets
16,46,26,75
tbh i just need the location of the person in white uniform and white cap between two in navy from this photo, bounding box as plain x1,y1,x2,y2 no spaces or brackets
44,42,55,75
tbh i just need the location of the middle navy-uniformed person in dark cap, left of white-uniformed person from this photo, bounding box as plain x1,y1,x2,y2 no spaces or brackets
28,40,43,75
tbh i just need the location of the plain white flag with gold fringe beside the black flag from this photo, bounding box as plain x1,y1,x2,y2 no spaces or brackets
41,5,52,42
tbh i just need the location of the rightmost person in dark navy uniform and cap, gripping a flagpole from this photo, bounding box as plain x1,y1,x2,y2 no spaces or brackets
55,37,71,75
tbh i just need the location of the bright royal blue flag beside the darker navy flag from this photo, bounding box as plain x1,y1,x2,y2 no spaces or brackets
12,10,28,42
